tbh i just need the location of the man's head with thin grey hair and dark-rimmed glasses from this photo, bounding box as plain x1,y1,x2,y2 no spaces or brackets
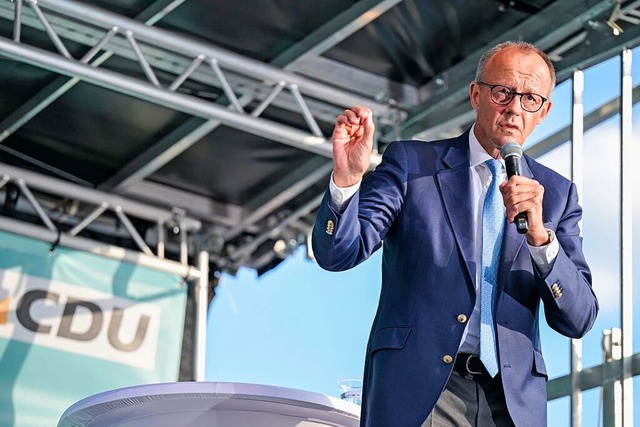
469,42,555,158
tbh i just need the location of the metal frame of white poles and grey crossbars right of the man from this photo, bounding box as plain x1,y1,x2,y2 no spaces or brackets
527,48,640,426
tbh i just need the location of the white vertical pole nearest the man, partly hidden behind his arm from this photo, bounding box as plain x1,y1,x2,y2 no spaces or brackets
571,70,584,427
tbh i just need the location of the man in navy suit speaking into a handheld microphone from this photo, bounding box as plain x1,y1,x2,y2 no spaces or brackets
313,42,598,427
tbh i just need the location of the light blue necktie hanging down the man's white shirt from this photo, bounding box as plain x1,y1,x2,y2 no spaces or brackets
480,159,505,377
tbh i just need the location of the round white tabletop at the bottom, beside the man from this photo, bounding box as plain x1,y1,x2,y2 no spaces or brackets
58,382,360,427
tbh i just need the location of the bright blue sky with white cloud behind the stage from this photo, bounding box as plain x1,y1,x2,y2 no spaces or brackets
206,48,640,427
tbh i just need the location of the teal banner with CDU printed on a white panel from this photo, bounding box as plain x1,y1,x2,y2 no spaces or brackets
0,231,187,427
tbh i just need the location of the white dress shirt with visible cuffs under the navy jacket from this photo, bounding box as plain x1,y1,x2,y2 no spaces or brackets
329,125,560,354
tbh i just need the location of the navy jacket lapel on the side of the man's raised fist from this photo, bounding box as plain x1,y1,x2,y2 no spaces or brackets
436,132,475,284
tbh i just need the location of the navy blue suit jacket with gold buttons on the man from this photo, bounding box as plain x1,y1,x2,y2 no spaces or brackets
312,132,598,427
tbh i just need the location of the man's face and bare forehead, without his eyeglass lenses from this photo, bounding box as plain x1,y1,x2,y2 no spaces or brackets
469,47,551,158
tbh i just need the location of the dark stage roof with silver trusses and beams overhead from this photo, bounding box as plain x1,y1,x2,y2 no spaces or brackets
0,0,640,274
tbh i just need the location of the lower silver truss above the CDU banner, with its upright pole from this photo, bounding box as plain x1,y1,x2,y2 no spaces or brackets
0,164,210,381
